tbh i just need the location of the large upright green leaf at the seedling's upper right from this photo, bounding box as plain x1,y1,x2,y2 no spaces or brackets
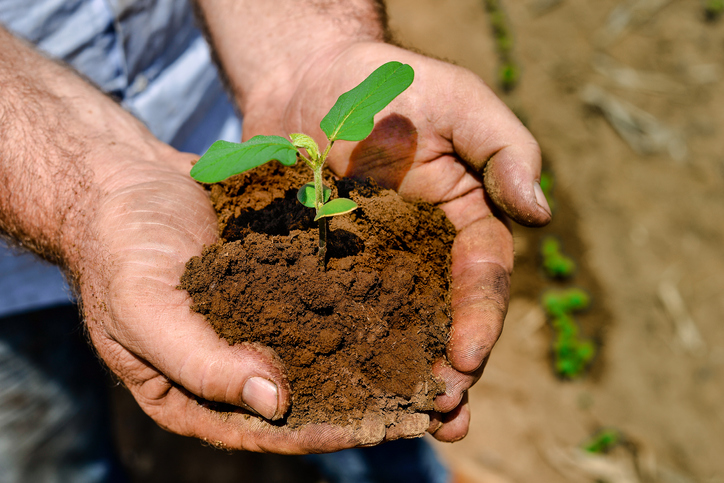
320,62,415,142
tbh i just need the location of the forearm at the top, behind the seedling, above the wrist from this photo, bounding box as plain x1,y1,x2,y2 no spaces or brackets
197,0,388,116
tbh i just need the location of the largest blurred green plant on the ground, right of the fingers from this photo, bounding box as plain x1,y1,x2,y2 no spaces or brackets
542,288,596,379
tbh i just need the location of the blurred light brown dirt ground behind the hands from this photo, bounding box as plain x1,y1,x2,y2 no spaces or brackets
110,0,724,483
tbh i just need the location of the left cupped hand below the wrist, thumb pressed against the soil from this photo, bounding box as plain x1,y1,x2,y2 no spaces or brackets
74,139,394,453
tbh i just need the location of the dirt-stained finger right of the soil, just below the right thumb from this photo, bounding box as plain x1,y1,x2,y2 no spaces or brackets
447,216,513,373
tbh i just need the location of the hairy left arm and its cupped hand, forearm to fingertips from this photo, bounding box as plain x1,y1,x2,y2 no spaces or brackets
0,24,384,453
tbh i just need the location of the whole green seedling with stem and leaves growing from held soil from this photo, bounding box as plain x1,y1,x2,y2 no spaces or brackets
191,62,414,268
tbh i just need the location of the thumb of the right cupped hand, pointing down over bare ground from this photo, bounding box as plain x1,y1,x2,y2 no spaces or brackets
448,70,551,226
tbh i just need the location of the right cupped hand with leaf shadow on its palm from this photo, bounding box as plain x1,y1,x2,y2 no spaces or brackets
244,42,550,441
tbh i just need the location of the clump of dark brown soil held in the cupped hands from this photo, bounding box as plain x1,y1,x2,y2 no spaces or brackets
181,163,455,427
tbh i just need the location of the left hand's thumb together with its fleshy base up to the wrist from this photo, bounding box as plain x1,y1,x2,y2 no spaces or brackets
88,182,290,419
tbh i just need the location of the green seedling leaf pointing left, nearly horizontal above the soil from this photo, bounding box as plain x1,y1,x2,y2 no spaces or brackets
191,136,297,183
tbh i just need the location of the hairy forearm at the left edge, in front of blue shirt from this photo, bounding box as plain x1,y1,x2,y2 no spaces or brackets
0,28,171,272
